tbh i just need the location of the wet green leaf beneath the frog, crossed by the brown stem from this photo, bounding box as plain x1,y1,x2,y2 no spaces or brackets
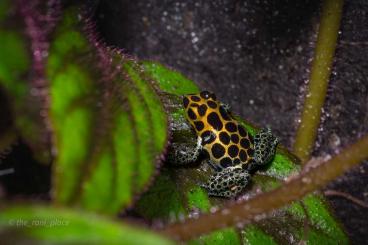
136,62,348,244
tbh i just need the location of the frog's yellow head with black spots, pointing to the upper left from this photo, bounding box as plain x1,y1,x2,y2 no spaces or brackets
183,91,219,131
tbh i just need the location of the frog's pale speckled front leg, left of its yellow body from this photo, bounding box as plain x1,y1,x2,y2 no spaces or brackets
168,137,202,165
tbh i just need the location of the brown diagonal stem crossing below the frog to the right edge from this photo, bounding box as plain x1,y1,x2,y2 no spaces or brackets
162,135,368,240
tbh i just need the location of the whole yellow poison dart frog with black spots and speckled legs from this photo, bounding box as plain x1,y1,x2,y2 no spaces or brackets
173,91,278,198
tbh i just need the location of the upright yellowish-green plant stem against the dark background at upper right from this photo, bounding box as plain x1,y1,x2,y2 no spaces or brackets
294,0,344,163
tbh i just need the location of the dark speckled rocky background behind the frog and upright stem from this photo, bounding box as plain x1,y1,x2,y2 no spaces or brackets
95,0,368,244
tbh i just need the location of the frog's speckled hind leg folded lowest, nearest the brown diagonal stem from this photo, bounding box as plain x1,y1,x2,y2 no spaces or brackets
202,167,250,198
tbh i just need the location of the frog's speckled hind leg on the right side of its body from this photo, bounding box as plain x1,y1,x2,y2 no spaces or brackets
254,128,278,165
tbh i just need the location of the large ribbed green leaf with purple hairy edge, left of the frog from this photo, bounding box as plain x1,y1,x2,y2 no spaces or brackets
47,9,167,214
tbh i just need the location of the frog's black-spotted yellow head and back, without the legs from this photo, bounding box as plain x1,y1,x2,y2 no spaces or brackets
183,91,254,168
